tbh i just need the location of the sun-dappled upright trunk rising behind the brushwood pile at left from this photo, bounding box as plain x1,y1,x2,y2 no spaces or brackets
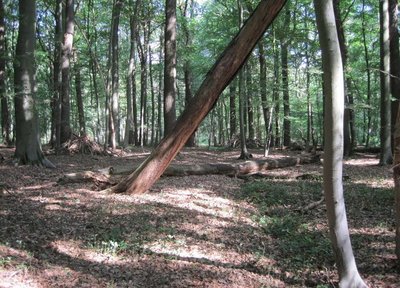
60,0,75,143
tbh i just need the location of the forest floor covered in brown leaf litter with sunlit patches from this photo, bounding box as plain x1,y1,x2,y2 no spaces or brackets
0,147,400,288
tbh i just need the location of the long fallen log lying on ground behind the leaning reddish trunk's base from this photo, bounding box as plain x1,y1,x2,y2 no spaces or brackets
58,154,320,186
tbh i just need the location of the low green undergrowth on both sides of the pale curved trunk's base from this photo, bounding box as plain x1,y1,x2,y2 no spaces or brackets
241,173,394,287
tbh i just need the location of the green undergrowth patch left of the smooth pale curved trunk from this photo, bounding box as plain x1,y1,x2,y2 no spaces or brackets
242,179,332,277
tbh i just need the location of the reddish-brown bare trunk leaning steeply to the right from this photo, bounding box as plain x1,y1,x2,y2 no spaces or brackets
106,0,285,194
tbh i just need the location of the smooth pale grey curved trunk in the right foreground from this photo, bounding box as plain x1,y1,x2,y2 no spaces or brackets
314,0,367,287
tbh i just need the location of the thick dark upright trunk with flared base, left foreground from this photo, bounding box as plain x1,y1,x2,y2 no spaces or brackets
14,0,54,168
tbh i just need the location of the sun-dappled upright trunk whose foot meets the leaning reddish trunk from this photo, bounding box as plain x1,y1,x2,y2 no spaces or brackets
164,0,176,134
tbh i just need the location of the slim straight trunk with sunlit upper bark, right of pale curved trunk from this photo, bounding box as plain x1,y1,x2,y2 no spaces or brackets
379,0,392,165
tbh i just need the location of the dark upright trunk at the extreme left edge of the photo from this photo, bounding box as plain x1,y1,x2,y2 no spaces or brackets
0,0,11,145
